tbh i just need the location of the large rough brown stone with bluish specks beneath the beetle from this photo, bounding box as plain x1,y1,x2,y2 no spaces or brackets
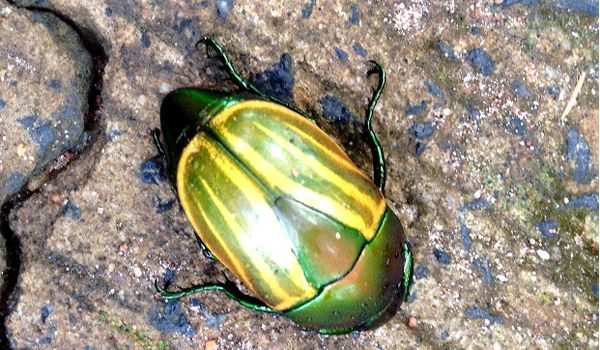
2,0,599,349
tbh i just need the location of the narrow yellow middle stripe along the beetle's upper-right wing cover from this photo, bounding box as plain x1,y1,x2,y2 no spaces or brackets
254,123,383,239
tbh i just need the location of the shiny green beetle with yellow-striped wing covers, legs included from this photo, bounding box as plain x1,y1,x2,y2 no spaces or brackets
152,38,413,334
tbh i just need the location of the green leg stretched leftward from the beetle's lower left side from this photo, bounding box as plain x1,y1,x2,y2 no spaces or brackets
154,278,277,313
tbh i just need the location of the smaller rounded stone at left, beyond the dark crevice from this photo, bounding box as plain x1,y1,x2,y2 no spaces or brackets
0,1,91,296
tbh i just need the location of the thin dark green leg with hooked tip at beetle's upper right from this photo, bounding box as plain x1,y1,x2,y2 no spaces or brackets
366,61,386,192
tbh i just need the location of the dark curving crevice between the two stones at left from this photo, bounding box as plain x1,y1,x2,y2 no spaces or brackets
0,1,108,349
